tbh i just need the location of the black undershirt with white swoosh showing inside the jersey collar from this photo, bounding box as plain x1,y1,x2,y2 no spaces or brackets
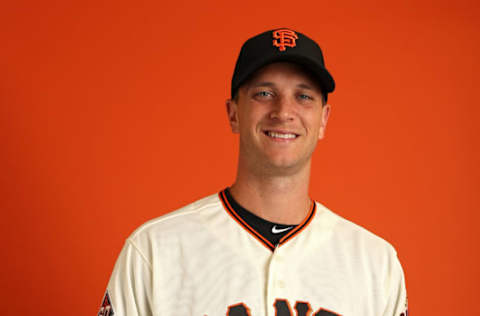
225,188,298,246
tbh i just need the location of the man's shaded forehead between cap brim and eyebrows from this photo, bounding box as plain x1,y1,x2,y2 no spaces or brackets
243,62,321,92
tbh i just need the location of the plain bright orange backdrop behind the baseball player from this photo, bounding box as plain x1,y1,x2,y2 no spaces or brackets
0,0,480,315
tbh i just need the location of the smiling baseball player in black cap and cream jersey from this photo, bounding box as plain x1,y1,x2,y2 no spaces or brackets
98,28,408,316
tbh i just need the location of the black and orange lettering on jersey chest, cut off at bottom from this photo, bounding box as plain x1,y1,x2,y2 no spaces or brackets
227,299,340,316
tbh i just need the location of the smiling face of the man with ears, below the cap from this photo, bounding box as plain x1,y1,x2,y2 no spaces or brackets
227,63,330,173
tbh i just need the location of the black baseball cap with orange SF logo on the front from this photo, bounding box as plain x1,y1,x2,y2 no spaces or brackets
231,28,335,99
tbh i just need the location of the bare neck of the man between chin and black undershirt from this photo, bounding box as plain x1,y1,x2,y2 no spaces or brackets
230,162,311,225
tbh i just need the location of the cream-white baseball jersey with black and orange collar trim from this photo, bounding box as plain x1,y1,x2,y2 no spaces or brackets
98,192,407,316
